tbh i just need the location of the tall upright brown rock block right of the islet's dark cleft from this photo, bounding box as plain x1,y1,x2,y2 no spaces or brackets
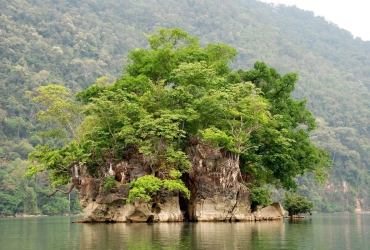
187,144,252,221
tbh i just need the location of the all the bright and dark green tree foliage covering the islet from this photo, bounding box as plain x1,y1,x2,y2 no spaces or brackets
27,28,330,205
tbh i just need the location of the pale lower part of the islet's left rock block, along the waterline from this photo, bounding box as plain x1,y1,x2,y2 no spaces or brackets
78,178,183,222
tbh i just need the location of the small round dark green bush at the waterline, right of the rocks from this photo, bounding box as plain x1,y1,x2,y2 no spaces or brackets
284,193,314,216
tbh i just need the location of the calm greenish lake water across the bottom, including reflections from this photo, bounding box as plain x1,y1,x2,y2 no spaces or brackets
0,214,370,250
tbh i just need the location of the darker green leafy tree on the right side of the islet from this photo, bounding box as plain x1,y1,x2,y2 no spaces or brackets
238,62,330,189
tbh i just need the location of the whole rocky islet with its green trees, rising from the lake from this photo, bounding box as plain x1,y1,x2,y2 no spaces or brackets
27,28,329,222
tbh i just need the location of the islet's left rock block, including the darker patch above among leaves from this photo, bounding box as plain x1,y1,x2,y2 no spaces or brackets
73,155,184,222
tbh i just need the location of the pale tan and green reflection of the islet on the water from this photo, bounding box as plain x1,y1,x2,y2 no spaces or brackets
80,220,285,250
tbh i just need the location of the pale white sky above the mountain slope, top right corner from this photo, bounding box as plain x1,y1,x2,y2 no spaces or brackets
260,0,370,41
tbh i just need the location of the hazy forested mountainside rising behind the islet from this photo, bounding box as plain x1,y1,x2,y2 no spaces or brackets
0,0,370,215
